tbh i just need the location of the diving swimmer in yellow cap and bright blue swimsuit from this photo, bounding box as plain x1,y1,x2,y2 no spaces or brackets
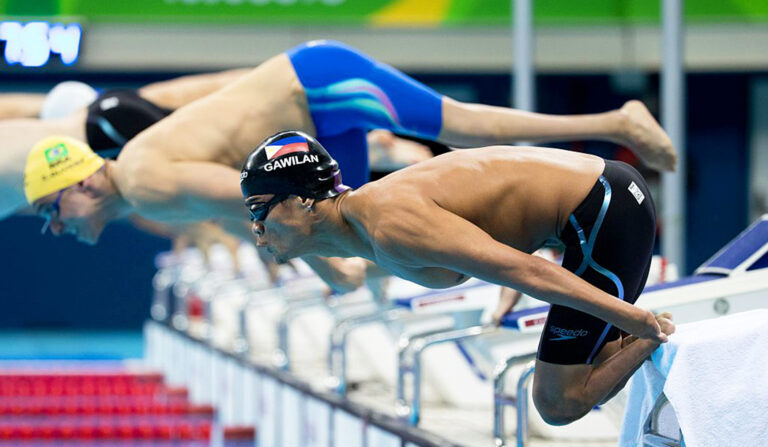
25,41,676,288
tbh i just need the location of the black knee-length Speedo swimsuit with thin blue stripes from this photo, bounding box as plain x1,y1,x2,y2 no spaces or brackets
538,160,656,365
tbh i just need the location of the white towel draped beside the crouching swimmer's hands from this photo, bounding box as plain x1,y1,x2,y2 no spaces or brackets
619,309,768,447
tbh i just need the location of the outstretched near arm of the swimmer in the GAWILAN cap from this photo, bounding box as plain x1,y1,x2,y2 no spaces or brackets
373,201,666,342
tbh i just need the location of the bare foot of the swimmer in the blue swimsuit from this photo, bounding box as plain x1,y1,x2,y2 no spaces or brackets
618,100,677,171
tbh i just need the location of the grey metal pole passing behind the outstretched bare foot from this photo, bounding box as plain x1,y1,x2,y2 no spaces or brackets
661,0,687,273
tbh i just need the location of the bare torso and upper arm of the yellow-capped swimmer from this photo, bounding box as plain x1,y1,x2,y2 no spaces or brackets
112,54,315,226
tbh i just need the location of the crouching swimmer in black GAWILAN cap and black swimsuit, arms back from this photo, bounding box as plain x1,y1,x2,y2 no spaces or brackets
241,132,673,424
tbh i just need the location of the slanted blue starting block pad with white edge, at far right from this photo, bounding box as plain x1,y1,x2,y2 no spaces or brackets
696,214,768,276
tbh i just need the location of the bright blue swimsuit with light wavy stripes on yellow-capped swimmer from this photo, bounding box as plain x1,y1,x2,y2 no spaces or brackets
286,40,442,188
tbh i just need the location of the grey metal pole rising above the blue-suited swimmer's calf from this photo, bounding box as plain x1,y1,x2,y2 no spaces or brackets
512,0,536,111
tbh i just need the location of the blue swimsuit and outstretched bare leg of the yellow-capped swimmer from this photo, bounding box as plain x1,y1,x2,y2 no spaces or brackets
286,41,675,187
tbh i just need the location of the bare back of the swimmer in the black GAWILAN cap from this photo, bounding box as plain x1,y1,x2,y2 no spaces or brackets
347,146,604,253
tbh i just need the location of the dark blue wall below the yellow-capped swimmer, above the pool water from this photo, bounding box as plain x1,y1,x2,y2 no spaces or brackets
0,216,170,329
